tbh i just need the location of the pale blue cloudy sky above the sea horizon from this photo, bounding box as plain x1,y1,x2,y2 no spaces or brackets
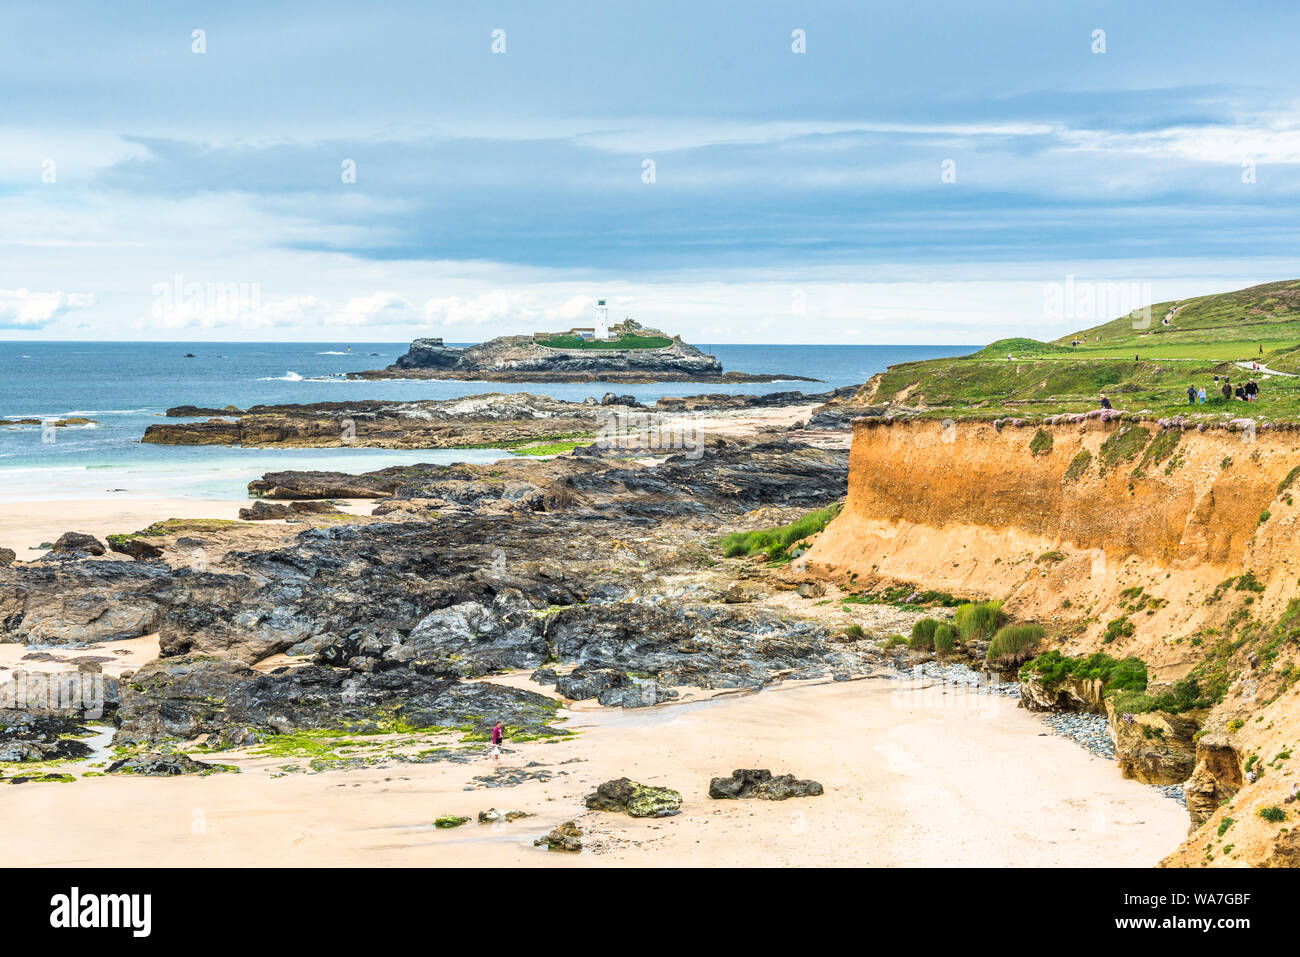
0,0,1300,343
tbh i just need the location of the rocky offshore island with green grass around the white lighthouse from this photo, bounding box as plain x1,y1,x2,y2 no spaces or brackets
348,319,816,384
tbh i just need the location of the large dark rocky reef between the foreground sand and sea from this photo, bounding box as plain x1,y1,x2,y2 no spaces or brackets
0,441,878,746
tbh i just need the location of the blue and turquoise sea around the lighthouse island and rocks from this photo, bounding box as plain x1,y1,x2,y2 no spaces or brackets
0,341,975,502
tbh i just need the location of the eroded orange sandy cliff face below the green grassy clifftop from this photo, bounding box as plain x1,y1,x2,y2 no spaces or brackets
807,417,1300,863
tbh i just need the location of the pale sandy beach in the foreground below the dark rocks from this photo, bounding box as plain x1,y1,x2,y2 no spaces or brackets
0,676,1187,867
